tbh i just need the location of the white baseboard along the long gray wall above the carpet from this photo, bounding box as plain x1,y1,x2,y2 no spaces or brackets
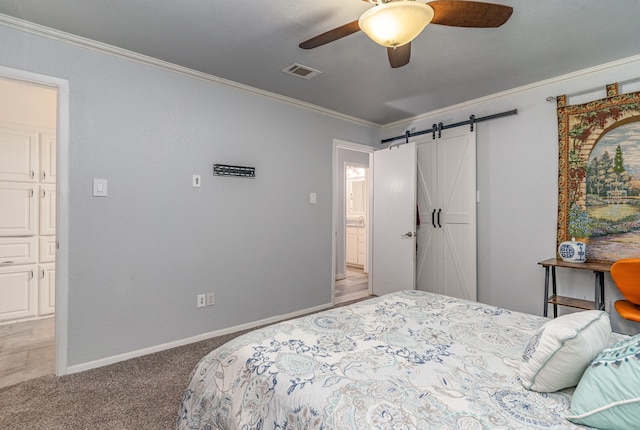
67,303,333,373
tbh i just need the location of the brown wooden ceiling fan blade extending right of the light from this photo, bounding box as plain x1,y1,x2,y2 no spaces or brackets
427,0,513,28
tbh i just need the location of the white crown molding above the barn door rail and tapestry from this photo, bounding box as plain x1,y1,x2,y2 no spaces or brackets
382,55,640,130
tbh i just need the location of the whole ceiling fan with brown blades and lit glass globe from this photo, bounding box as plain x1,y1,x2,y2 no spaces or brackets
298,0,513,68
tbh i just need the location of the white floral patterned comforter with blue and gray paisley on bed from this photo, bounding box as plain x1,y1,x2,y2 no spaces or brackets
176,291,592,430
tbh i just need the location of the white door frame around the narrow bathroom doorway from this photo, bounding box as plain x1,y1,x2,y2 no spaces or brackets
331,139,375,304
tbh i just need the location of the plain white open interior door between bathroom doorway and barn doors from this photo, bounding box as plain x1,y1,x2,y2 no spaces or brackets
371,142,416,296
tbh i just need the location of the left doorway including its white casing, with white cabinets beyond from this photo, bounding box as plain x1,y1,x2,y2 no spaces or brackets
0,66,69,385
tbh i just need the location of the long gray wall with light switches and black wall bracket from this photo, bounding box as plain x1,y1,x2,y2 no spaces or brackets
0,22,380,366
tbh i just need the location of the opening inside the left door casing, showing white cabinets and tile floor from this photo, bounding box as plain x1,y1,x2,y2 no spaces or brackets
0,78,58,386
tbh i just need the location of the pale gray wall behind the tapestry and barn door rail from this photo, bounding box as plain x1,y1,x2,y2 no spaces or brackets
383,57,640,332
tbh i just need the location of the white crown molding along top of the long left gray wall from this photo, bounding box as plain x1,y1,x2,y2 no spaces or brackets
0,14,380,129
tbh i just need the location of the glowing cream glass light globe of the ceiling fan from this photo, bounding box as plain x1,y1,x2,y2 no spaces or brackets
358,0,434,48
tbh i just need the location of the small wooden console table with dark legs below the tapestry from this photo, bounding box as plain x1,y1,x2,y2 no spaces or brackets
538,258,611,318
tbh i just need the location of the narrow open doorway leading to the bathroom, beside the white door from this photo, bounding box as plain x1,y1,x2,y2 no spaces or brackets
332,140,373,304
